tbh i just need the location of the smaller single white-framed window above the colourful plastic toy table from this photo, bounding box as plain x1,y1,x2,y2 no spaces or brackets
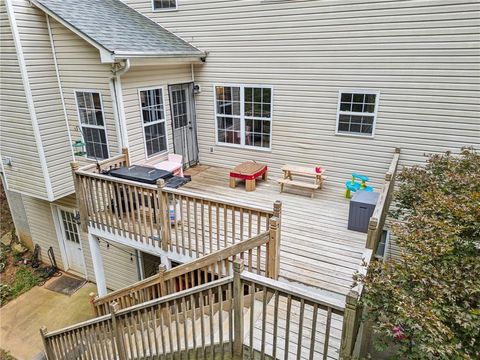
336,90,379,137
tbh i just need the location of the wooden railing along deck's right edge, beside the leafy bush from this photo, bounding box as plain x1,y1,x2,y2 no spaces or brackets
341,148,400,359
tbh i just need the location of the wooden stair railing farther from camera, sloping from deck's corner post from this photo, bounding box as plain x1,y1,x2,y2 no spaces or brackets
92,218,280,316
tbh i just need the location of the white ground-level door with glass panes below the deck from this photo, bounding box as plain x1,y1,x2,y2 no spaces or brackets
58,208,85,274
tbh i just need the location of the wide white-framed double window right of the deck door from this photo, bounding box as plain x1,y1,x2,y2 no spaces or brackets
215,85,273,149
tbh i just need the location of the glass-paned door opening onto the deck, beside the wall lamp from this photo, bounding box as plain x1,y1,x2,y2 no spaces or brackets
168,83,198,167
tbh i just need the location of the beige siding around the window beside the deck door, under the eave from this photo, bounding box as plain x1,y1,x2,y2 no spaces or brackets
121,65,192,163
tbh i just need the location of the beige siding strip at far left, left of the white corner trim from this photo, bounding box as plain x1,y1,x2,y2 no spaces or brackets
0,0,47,199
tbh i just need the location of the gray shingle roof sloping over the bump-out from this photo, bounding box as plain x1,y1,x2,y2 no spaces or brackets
32,0,204,56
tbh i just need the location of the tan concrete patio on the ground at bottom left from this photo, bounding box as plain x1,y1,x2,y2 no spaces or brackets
0,278,96,360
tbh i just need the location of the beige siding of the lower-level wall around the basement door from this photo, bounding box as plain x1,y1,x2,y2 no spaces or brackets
23,195,138,290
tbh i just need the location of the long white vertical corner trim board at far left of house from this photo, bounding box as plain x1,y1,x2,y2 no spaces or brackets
5,0,55,201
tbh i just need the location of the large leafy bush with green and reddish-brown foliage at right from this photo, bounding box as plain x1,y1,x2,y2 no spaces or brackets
361,149,480,360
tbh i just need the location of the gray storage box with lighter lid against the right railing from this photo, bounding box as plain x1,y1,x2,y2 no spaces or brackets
348,190,379,233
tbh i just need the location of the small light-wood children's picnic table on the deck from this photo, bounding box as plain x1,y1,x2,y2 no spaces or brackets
278,165,326,199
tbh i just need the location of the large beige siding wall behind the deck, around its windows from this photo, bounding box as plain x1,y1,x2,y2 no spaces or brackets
125,0,480,187
